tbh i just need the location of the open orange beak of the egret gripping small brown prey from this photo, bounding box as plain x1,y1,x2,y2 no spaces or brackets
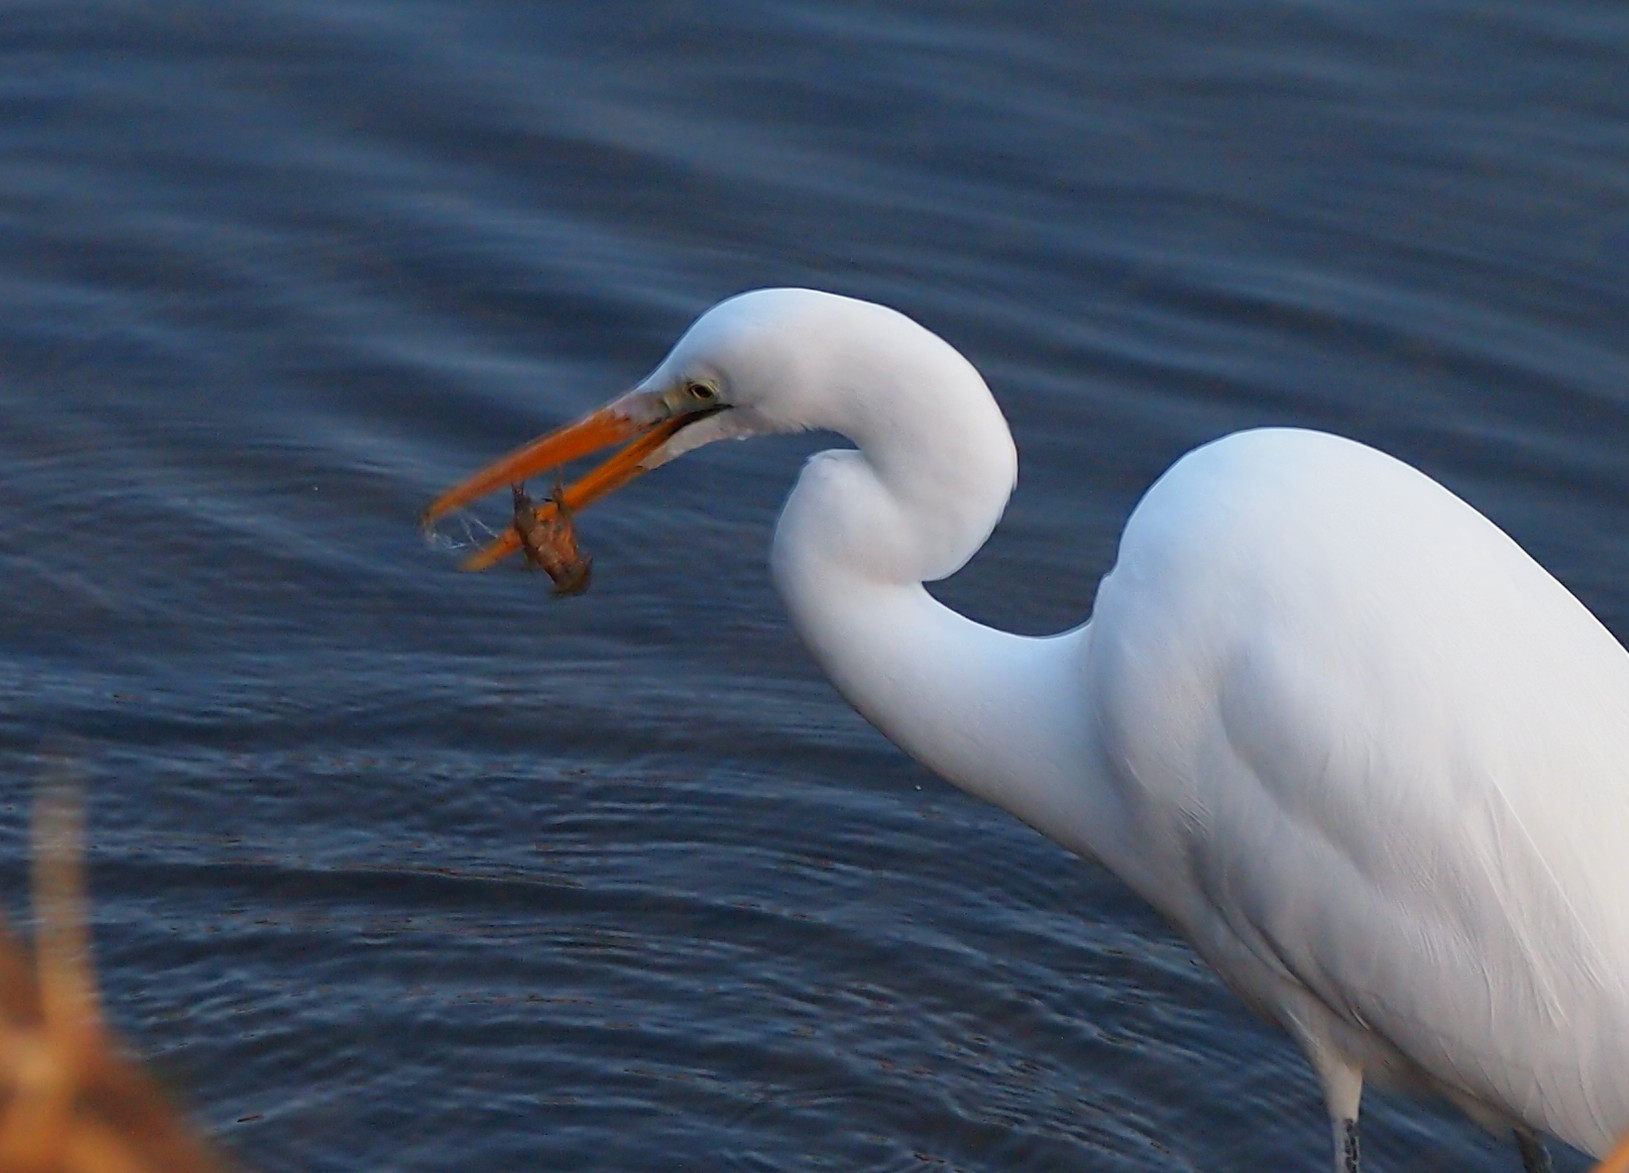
422,391,712,570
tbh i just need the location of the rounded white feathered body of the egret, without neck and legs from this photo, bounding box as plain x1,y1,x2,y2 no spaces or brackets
1074,430,1629,1153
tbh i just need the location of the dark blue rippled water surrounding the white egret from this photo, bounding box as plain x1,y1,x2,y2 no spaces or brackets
0,0,1629,1173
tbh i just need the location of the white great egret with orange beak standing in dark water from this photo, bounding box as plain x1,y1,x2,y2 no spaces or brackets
425,288,1629,1173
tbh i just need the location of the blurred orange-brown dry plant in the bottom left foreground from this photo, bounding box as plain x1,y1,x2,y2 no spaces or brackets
0,784,226,1173
